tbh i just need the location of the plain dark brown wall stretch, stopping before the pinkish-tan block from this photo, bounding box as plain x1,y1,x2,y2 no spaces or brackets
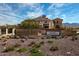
16,29,39,36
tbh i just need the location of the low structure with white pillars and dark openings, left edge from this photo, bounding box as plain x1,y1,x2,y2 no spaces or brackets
0,25,15,38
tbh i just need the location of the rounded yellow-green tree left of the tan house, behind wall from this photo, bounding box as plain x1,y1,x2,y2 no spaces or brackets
20,19,39,29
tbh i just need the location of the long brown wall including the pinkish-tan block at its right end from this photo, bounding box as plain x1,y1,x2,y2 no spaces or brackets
16,29,46,36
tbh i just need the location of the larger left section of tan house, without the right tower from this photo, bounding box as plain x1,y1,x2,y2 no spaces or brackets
35,15,54,29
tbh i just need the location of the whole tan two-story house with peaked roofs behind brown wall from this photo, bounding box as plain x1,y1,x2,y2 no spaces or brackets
35,15,63,29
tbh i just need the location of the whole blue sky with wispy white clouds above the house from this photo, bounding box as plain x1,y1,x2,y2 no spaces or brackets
0,3,79,25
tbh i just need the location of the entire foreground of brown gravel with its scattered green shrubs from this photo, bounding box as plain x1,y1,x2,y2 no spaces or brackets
0,35,79,56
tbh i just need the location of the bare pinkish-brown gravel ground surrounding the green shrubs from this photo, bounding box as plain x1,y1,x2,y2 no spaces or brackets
0,36,79,56
